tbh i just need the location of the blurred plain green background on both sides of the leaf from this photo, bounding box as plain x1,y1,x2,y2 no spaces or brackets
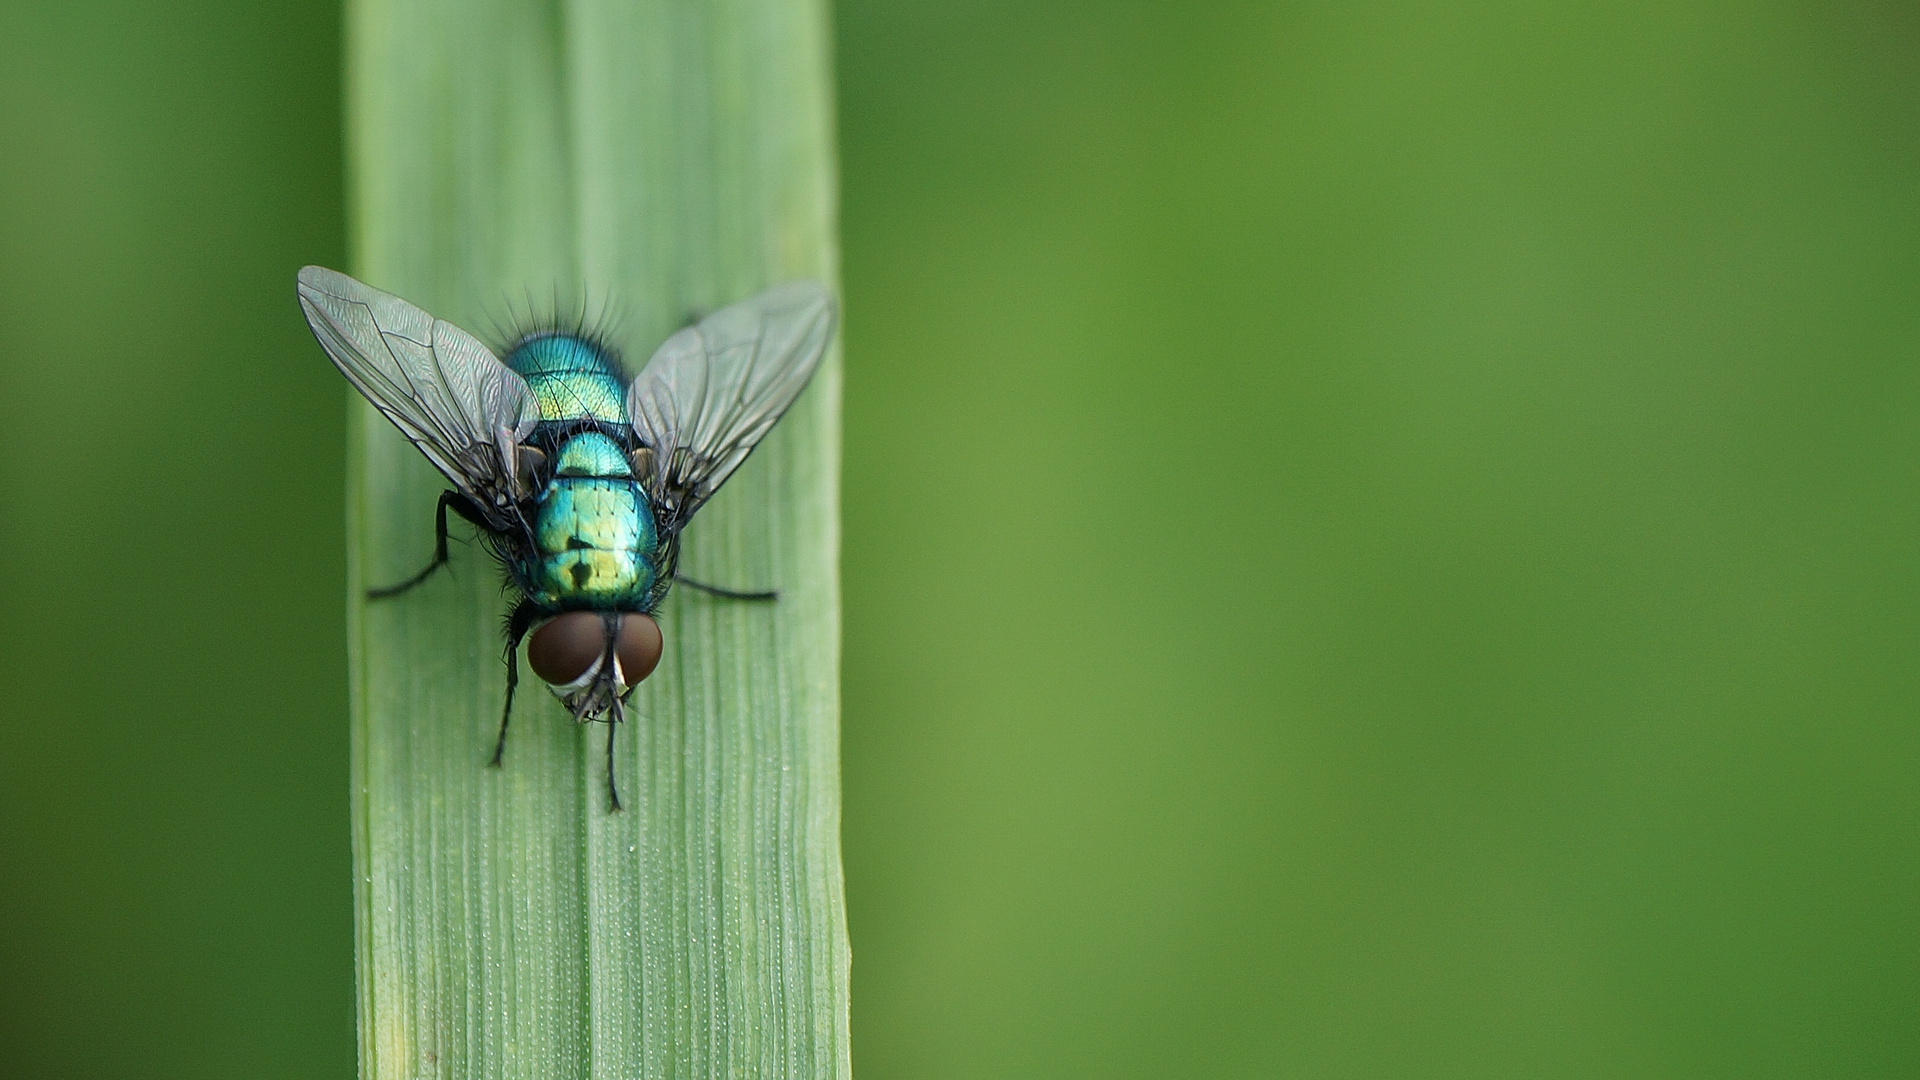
0,0,1920,1080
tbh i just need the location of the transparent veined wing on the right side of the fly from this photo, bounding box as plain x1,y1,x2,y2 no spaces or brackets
626,281,833,525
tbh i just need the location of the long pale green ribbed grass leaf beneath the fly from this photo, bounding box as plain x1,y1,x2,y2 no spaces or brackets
348,0,849,1080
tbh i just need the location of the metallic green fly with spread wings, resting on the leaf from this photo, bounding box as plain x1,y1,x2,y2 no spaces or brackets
300,267,833,809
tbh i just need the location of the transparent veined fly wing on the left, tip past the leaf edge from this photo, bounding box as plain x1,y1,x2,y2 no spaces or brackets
300,267,540,515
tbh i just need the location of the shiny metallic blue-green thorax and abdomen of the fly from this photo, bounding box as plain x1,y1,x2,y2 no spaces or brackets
507,334,660,611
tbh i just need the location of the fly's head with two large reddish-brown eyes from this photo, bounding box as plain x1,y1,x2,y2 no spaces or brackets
526,611,662,721
